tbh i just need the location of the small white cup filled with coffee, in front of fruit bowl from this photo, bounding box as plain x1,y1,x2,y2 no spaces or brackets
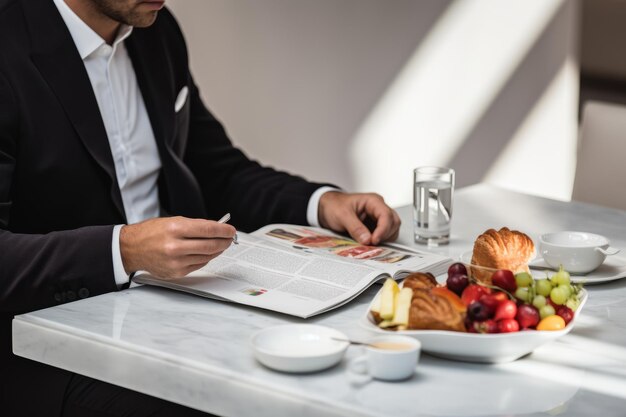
349,335,422,381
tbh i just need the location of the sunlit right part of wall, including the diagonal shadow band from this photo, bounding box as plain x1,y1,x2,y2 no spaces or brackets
349,0,577,205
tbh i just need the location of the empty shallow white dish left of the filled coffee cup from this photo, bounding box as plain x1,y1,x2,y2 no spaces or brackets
250,324,348,372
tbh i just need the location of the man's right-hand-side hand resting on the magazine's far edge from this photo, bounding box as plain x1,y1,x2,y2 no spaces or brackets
318,191,400,245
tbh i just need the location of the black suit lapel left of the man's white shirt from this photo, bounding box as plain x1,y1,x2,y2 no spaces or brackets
22,0,126,219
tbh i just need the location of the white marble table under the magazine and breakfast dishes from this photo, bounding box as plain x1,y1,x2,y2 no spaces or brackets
13,184,626,417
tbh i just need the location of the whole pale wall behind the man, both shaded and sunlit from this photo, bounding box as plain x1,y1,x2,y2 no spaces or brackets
168,0,578,204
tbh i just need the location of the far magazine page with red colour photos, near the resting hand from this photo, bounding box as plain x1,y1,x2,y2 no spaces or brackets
252,224,451,279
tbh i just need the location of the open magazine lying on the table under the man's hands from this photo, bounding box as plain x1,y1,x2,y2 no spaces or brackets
133,224,452,318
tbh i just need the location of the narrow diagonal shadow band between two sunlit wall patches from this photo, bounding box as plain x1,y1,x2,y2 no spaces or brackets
449,2,571,187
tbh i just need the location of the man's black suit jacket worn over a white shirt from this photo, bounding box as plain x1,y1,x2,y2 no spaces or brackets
0,0,320,410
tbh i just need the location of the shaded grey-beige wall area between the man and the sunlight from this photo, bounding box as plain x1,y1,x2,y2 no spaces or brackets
168,0,452,189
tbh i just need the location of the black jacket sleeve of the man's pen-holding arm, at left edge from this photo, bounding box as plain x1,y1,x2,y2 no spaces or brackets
0,73,117,314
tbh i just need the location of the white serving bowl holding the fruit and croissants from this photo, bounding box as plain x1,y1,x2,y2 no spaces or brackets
359,289,587,363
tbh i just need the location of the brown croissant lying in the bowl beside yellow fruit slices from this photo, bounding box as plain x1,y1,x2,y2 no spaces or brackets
408,288,465,332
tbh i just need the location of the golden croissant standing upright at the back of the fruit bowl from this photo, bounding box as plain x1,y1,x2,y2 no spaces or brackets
472,227,535,284
